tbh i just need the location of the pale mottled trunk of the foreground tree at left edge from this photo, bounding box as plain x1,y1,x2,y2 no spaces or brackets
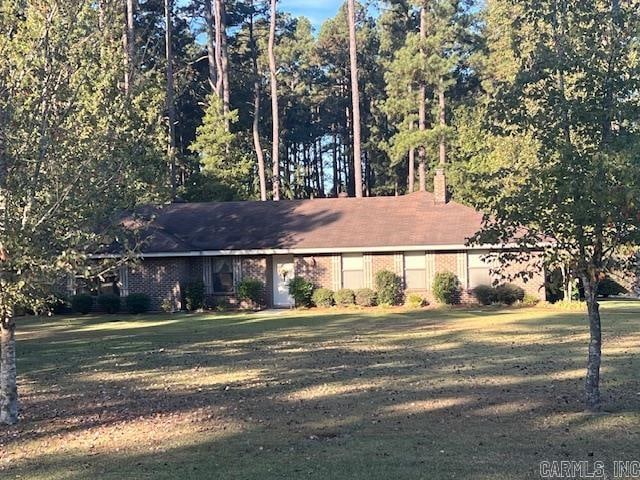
0,314,18,425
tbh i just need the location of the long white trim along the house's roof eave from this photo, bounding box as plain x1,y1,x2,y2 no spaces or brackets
90,243,551,259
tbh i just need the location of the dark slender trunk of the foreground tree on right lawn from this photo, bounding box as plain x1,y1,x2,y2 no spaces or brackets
581,272,602,412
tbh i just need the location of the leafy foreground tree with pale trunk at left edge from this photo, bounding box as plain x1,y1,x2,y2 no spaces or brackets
0,1,162,424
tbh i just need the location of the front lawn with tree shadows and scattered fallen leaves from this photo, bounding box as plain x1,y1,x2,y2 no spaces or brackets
0,302,640,480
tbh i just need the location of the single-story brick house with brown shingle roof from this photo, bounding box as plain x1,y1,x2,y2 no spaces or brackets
85,192,545,310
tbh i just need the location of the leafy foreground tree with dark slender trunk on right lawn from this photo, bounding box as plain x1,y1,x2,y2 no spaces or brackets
459,0,640,412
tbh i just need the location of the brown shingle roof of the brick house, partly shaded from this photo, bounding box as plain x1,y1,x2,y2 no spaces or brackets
126,192,482,253
